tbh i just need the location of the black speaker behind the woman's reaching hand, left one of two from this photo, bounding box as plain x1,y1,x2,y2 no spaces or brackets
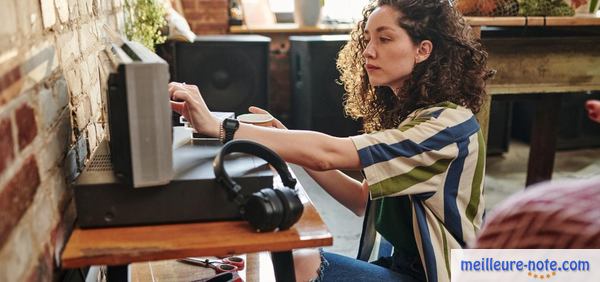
157,35,271,115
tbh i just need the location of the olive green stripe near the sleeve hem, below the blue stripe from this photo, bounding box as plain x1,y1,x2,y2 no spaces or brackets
369,158,453,198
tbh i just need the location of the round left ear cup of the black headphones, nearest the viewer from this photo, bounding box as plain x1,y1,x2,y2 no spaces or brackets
244,188,284,232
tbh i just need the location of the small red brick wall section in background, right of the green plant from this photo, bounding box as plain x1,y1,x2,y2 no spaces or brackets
181,0,229,35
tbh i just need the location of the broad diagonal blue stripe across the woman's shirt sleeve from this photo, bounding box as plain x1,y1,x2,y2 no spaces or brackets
358,116,479,168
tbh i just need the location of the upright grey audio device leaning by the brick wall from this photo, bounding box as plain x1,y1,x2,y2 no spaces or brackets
106,40,174,188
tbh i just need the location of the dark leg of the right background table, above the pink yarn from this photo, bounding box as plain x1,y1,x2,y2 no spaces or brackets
525,93,561,187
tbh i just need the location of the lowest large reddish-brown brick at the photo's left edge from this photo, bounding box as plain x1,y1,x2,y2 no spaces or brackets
0,156,40,249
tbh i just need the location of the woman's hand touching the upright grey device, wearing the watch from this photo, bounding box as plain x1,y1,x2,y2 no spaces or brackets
169,82,221,137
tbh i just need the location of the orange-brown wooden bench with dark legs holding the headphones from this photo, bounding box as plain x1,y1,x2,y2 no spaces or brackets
61,177,333,281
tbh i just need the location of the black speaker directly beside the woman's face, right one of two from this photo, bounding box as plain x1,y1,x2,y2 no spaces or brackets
289,35,361,137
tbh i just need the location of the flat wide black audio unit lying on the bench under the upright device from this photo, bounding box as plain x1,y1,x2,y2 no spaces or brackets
75,130,273,228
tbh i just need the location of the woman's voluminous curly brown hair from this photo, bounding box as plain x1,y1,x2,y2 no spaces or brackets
337,0,494,132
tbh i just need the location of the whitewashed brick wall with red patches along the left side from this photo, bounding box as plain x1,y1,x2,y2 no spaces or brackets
0,0,124,281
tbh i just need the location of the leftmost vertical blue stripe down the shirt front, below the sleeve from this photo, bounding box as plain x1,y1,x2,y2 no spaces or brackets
411,198,438,282
